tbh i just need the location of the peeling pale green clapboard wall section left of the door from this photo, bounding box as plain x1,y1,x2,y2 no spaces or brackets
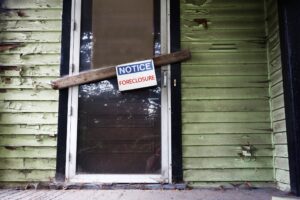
0,0,62,186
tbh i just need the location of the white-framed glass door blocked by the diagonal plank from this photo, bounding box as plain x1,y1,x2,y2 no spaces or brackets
66,0,171,183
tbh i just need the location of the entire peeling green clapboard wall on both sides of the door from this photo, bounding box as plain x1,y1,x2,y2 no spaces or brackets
0,0,289,189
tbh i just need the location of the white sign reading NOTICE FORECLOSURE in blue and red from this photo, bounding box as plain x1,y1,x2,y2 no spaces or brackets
116,60,157,91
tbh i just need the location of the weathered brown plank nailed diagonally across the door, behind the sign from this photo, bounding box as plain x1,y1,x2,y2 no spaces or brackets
52,50,191,89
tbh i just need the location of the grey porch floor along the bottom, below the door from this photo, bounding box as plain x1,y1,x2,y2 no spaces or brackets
0,189,300,200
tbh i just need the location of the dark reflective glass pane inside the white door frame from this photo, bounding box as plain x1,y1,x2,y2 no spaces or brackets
76,0,161,174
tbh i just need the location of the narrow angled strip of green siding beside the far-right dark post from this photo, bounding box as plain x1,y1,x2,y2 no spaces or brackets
266,0,290,191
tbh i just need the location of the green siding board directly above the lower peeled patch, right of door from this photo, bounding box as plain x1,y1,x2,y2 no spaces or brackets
182,134,272,146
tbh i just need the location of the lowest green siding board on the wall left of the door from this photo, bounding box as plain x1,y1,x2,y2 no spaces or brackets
0,169,55,183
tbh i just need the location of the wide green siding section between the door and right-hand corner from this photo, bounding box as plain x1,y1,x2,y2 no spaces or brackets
181,0,274,186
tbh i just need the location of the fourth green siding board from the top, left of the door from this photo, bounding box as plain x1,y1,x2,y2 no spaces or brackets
0,31,61,43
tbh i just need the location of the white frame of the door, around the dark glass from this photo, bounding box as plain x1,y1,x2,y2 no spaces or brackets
66,0,172,183
